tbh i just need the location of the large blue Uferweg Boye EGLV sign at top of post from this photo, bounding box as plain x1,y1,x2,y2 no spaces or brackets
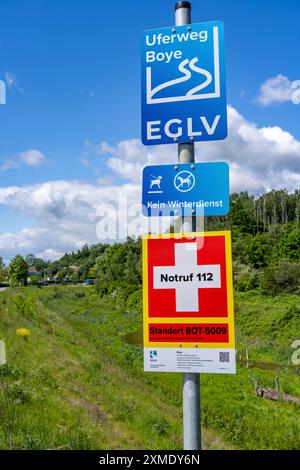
142,21,227,145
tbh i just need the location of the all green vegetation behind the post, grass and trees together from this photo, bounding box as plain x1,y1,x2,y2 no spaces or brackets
0,186,300,449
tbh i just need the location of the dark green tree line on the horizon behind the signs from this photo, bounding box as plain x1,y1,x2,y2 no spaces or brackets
0,190,300,294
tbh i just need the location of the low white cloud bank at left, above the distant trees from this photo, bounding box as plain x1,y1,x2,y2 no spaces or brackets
0,181,140,259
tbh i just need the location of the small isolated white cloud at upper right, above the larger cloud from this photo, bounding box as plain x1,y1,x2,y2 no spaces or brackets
258,74,293,106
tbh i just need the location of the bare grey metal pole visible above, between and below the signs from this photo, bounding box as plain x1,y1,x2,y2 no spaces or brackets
175,2,201,450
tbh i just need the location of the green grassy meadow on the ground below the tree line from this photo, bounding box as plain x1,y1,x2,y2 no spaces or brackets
0,287,300,450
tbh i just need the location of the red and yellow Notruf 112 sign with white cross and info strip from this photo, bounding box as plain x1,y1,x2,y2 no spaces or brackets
143,232,235,373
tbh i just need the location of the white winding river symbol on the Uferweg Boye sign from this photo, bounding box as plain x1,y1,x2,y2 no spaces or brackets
148,57,212,100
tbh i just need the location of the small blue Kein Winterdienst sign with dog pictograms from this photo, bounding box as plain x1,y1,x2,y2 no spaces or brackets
143,162,229,217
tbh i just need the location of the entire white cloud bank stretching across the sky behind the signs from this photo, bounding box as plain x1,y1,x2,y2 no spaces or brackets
0,107,300,258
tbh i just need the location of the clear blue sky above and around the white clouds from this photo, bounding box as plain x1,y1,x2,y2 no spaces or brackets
0,0,300,257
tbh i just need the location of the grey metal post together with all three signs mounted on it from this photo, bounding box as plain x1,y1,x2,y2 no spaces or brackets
141,1,232,450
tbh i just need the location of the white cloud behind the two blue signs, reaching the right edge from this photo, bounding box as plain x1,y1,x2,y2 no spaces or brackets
100,106,300,193
